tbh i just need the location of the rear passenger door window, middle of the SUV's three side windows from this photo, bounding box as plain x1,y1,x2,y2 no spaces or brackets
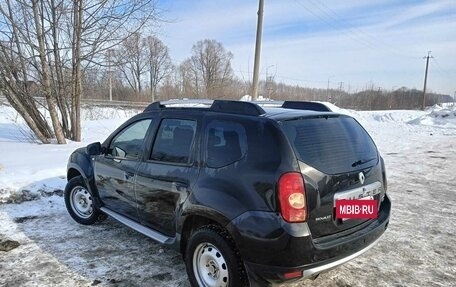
150,119,196,163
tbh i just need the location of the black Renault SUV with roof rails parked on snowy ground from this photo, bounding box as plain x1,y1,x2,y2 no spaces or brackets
65,100,391,287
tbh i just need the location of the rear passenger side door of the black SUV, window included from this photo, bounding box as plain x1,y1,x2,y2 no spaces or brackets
136,116,201,236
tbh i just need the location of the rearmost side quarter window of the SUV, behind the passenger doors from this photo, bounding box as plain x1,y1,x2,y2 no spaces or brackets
206,120,247,168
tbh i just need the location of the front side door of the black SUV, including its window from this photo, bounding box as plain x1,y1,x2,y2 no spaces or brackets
94,119,152,221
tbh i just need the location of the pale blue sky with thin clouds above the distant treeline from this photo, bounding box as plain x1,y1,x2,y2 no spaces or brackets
158,0,456,96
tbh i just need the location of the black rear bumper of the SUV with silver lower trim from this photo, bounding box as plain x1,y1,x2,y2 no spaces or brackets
228,196,391,283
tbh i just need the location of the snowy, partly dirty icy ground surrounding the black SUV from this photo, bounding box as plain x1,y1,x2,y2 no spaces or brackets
0,105,456,287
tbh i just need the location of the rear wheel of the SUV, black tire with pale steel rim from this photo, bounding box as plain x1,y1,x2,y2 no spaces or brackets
185,225,249,287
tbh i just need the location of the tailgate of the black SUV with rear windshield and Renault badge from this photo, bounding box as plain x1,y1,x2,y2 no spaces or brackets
282,115,384,237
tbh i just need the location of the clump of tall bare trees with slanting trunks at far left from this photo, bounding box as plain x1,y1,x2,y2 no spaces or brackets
0,0,158,143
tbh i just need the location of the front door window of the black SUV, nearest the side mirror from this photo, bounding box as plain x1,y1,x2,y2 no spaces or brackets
108,119,152,159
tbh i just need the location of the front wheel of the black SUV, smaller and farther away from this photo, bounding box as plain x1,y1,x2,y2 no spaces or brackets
64,176,106,225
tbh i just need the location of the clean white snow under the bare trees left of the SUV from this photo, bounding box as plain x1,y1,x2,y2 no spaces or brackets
0,105,140,203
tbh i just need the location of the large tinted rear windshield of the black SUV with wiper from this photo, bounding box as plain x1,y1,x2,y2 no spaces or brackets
283,116,377,174
